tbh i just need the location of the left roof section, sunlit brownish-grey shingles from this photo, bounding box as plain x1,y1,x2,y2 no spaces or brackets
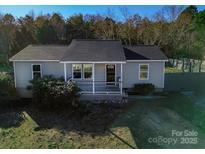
10,45,68,61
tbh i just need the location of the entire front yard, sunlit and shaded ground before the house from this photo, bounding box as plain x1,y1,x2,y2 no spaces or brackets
0,91,205,148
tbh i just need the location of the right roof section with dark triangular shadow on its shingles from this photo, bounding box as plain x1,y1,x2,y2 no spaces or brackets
124,45,167,60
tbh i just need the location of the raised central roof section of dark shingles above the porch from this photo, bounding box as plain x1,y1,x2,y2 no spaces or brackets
61,40,126,61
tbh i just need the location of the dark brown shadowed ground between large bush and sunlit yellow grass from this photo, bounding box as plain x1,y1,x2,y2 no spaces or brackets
25,104,126,135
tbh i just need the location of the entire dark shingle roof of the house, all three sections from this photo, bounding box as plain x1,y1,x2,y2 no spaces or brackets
10,40,167,62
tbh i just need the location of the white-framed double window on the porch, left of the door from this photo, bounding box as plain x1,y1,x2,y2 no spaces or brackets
73,64,92,79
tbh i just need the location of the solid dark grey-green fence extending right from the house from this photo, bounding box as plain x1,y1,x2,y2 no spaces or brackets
164,73,205,91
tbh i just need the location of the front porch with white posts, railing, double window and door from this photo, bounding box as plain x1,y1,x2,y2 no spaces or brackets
64,62,123,95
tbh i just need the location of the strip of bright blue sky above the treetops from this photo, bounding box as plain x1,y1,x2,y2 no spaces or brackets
0,5,205,20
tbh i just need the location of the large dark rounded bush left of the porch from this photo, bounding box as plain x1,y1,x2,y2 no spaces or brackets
28,76,80,107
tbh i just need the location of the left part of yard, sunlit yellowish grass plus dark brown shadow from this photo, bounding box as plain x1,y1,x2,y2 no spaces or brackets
0,104,136,149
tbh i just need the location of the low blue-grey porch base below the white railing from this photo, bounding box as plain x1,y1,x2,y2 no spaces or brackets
80,93,128,103
